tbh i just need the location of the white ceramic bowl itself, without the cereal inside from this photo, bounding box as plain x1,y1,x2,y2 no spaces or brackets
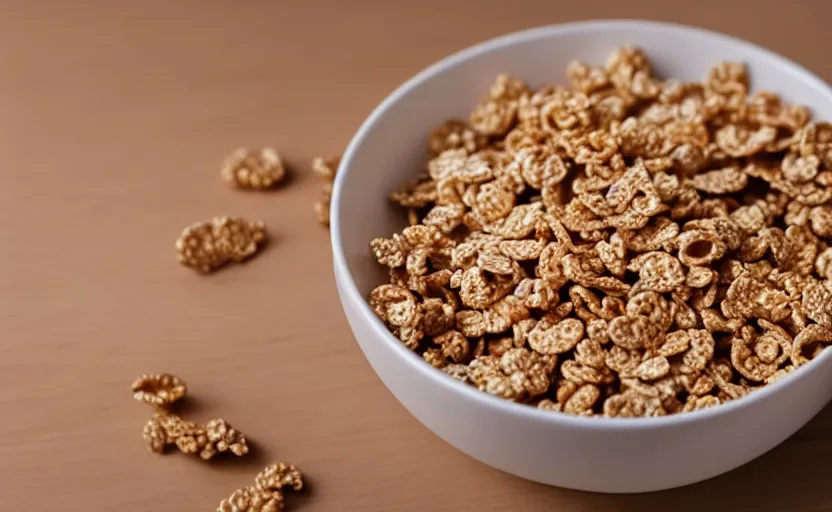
332,21,832,492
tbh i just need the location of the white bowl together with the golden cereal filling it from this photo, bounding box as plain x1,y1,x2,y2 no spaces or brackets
331,21,832,493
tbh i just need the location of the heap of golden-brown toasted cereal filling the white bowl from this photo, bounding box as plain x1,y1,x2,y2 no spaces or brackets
369,47,832,417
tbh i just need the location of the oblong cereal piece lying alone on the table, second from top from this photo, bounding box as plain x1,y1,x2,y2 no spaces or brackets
176,217,266,273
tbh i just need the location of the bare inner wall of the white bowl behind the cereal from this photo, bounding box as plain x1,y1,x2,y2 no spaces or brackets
332,21,832,298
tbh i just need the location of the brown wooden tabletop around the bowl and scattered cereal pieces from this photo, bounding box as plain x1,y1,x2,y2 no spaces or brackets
0,0,832,512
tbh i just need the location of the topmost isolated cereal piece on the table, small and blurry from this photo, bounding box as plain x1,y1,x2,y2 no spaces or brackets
220,148,286,190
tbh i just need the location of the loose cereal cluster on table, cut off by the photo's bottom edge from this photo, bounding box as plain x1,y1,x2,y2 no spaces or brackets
217,462,303,512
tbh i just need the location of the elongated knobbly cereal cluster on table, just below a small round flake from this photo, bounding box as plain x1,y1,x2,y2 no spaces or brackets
142,412,248,460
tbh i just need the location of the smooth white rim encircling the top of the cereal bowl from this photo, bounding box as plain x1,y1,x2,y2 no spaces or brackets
330,19,832,431
